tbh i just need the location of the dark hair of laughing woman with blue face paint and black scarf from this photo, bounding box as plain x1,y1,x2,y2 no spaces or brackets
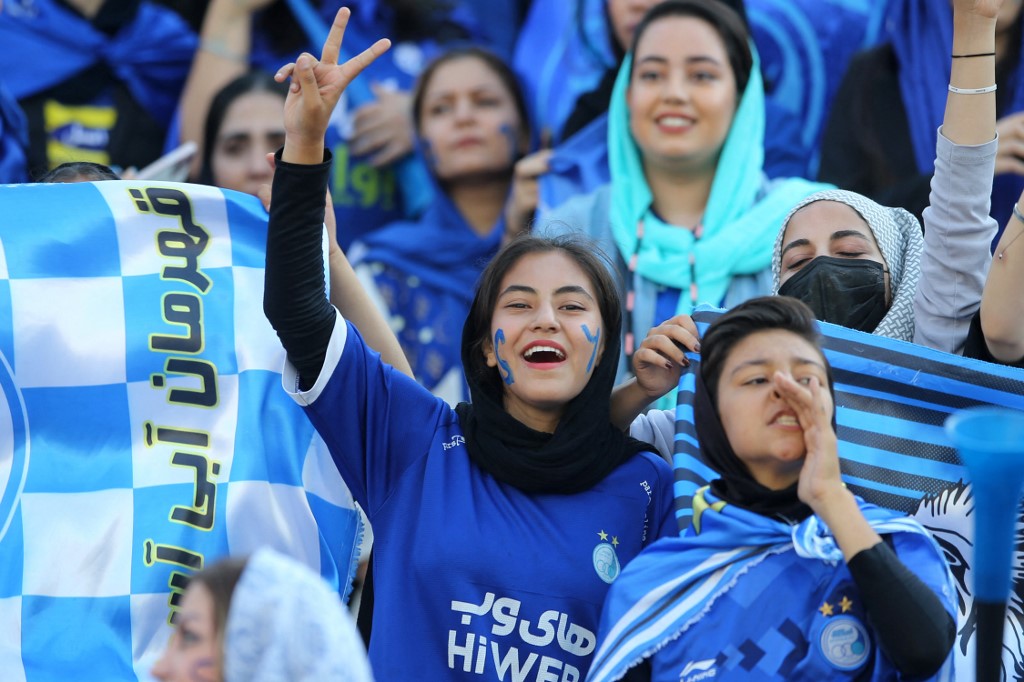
462,232,623,394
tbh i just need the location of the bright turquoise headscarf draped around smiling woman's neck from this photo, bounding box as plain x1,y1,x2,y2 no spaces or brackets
608,44,831,313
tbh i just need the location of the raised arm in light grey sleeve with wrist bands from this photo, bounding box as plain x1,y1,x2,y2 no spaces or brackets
914,0,1002,352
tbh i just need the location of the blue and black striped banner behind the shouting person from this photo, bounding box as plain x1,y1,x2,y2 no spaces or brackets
674,306,1024,680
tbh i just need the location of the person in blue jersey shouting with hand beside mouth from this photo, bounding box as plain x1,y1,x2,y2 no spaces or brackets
588,296,956,682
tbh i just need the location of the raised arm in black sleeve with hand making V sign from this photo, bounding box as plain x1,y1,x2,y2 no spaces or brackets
263,7,390,389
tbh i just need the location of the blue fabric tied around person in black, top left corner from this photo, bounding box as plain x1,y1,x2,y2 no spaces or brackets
0,0,197,126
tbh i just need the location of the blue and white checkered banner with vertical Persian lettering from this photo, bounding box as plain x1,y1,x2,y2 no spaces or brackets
0,181,360,682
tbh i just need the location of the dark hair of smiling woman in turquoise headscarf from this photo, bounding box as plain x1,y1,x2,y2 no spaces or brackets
630,0,754,95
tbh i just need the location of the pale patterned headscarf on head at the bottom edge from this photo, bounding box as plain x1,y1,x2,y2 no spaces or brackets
224,549,373,682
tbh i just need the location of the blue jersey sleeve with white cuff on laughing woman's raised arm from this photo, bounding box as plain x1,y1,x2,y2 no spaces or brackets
283,314,457,519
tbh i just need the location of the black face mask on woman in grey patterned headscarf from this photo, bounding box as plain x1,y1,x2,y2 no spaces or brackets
778,256,889,332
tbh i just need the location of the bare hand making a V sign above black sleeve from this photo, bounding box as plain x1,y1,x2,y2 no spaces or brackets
274,7,391,163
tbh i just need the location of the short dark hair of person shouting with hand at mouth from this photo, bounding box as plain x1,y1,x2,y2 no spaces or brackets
700,296,833,409
